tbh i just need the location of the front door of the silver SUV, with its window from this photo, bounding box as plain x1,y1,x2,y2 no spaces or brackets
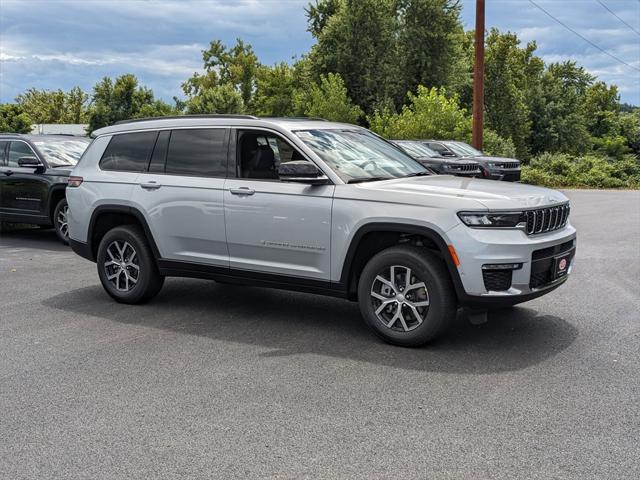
224,130,334,281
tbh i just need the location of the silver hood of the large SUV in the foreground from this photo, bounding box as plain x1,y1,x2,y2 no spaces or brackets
349,175,568,210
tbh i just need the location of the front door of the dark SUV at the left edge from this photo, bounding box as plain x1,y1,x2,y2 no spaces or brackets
0,140,49,220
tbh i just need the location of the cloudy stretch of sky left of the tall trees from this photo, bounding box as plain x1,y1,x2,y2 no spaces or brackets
0,0,312,102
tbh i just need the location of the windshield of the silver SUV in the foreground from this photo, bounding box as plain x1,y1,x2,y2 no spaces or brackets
294,130,429,183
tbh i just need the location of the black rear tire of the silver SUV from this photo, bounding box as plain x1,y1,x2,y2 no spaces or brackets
96,225,164,304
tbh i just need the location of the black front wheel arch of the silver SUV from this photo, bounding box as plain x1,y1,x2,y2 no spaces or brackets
340,222,465,300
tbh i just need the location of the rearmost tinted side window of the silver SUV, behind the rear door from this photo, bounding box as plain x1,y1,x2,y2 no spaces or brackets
100,132,158,172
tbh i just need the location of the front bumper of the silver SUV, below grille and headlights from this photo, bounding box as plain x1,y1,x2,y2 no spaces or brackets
447,224,576,304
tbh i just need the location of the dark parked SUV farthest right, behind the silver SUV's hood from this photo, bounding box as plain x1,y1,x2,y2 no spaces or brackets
422,140,520,182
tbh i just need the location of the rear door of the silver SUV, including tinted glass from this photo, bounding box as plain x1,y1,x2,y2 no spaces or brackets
132,127,229,267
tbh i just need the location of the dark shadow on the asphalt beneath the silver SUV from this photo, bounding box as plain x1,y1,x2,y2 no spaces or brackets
43,279,578,374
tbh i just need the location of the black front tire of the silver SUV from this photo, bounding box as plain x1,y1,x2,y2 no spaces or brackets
358,245,457,347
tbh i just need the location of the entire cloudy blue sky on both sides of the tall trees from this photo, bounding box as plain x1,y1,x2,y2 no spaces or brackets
0,0,640,105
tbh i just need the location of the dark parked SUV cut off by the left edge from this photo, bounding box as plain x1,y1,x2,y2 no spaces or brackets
0,134,90,243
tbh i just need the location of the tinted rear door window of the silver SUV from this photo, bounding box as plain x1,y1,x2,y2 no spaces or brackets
165,128,227,177
